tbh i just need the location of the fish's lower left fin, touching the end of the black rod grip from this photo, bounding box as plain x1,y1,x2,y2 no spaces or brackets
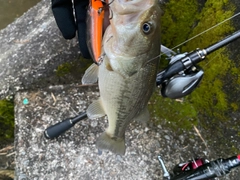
87,99,106,119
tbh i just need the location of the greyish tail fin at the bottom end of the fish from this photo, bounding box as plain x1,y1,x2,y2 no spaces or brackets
96,132,126,155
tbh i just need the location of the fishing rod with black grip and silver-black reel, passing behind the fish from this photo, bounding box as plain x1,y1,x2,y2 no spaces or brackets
44,31,240,139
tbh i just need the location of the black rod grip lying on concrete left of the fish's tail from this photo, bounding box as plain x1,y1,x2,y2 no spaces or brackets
44,112,87,139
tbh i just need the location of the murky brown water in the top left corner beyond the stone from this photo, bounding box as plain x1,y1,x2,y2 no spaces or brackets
0,0,40,29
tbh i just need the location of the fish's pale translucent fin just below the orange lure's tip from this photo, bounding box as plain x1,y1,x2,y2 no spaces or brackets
82,63,98,84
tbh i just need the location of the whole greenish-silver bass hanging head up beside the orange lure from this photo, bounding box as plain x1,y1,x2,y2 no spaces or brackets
82,0,162,155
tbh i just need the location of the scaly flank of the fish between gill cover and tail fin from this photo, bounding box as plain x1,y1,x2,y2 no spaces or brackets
96,60,157,153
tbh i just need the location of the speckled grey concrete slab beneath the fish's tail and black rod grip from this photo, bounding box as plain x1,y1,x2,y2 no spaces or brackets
15,84,240,180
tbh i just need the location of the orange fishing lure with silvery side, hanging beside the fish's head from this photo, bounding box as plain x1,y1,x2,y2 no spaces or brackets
87,0,106,64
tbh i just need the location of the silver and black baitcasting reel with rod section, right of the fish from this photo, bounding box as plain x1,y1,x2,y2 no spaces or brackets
156,31,240,99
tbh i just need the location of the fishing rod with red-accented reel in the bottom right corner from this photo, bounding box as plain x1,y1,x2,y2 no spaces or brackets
158,155,240,180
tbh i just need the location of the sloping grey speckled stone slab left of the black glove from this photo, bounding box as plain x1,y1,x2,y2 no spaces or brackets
0,0,79,99
